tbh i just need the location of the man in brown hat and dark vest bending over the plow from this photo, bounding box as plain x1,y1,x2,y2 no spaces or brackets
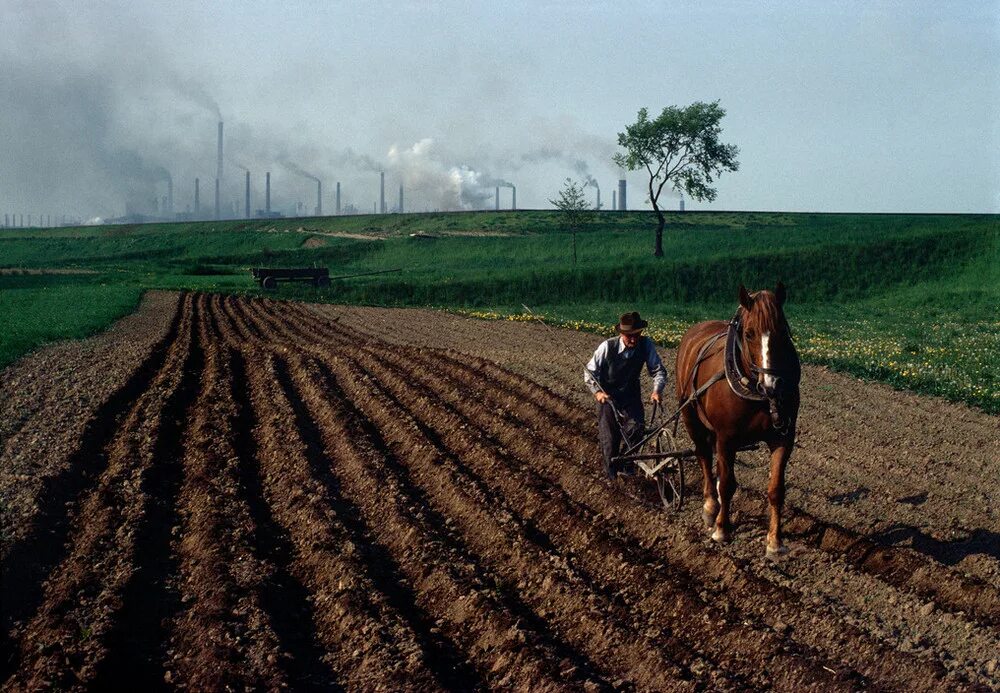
583,312,667,479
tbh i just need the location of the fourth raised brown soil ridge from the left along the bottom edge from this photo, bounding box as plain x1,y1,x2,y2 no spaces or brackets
284,354,609,690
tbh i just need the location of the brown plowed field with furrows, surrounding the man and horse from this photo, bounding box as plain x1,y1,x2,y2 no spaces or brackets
0,294,1000,691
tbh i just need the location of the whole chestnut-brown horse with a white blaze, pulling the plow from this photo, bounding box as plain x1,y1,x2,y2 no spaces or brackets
676,282,801,556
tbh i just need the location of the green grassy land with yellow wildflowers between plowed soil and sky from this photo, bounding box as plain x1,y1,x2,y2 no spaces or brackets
0,211,1000,413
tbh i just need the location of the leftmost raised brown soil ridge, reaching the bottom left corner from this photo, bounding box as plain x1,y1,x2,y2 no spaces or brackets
5,296,193,688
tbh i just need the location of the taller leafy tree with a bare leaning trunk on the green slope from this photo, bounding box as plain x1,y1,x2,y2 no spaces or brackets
614,101,740,257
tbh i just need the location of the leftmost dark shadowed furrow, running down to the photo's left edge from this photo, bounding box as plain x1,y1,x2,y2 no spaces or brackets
0,290,183,668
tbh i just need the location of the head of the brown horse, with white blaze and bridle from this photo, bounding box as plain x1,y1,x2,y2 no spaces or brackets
740,282,799,397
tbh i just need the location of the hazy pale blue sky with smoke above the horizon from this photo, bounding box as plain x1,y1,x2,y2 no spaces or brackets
0,0,1000,217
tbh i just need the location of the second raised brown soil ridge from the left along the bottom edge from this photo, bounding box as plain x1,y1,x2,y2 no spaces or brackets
165,298,288,690
